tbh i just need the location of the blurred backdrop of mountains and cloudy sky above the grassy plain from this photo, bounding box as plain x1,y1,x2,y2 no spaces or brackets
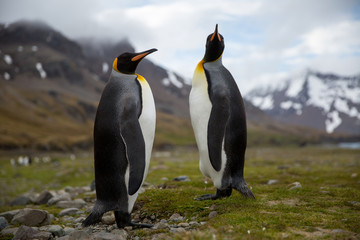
0,0,360,152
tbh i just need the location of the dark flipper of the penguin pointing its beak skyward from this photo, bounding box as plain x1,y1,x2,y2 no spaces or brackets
207,91,230,171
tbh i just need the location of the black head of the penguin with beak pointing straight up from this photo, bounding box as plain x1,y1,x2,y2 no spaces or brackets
204,24,225,62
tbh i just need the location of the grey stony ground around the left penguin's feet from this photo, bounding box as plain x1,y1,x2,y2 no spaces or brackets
0,179,210,240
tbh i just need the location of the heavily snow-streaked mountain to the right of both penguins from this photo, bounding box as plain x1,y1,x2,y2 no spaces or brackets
245,70,360,135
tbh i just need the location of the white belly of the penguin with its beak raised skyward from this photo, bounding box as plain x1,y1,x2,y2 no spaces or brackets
189,64,226,188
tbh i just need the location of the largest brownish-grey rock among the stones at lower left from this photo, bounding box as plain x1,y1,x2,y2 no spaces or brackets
11,208,50,227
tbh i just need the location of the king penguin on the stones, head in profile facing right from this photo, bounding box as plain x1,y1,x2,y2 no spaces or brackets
83,49,157,228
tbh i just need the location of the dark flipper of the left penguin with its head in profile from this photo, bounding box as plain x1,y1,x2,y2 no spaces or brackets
120,99,145,195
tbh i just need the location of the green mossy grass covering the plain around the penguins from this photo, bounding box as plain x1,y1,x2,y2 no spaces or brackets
0,147,360,239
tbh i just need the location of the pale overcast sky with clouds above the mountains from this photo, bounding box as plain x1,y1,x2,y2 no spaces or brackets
0,0,360,93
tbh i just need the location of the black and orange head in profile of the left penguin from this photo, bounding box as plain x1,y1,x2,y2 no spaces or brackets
113,48,157,74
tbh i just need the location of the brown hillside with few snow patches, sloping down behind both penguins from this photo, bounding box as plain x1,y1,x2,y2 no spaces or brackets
0,21,340,150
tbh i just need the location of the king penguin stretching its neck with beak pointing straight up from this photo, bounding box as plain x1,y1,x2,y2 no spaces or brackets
189,24,255,200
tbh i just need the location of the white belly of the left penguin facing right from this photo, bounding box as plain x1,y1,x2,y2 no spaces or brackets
125,77,156,213
